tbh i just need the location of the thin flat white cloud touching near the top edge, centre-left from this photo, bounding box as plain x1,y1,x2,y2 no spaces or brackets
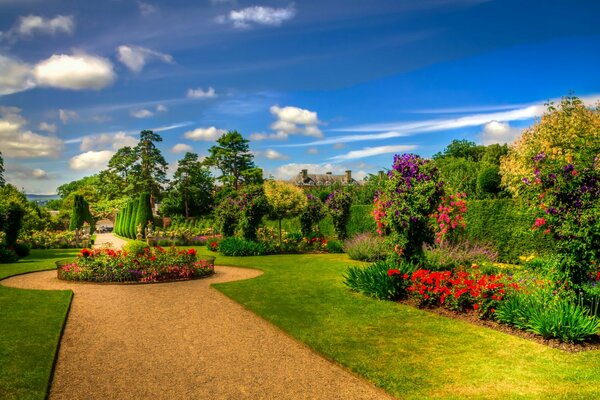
217,4,296,29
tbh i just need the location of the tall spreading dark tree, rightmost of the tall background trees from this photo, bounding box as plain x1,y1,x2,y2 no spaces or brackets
204,131,254,190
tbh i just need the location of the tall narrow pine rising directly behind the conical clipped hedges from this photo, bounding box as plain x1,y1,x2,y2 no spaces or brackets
134,130,168,207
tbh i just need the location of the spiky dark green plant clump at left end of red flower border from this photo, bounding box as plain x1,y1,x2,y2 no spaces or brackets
344,261,417,300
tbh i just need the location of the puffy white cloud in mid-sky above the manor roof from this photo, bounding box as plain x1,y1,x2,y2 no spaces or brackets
269,105,323,139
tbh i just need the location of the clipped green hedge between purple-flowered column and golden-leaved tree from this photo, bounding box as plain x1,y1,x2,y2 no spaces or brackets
464,199,553,262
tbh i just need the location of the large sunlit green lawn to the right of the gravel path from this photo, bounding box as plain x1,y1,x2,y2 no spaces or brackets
198,248,600,399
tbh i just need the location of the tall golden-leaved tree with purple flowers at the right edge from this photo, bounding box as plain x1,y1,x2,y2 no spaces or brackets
501,97,600,284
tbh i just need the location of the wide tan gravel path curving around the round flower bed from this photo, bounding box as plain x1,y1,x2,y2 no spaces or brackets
1,267,391,400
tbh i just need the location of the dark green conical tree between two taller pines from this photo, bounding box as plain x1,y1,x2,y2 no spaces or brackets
168,152,213,217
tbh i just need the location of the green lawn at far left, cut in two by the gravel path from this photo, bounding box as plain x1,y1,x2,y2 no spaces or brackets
0,250,78,399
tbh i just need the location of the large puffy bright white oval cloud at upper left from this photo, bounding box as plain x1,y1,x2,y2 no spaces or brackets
33,54,115,90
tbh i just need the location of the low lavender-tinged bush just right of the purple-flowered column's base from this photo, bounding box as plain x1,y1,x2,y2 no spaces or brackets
424,242,498,271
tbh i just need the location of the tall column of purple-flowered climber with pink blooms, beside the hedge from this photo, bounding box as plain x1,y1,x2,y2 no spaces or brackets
373,154,443,260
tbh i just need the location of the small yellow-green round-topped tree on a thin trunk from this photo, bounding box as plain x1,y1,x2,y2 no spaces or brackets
264,181,307,246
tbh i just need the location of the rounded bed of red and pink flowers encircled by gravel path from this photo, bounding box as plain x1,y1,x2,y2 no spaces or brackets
57,247,215,283
